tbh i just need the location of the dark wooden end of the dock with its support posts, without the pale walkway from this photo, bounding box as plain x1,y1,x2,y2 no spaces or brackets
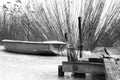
58,58,105,77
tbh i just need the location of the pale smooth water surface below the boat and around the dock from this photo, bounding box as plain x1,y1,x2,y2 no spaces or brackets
0,46,103,80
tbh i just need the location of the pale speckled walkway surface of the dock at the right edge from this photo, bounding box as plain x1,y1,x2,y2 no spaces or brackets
104,58,120,80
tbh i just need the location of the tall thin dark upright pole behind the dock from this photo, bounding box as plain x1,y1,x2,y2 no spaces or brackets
78,17,83,58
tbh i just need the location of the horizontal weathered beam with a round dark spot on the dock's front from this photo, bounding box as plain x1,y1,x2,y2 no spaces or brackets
62,61,105,74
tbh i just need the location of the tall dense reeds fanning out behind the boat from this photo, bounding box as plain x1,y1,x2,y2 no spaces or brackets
0,0,120,50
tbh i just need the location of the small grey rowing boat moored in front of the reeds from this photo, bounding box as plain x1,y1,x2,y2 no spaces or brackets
2,39,66,55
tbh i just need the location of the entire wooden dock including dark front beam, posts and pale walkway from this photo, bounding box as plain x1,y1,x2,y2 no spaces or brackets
58,58,120,80
